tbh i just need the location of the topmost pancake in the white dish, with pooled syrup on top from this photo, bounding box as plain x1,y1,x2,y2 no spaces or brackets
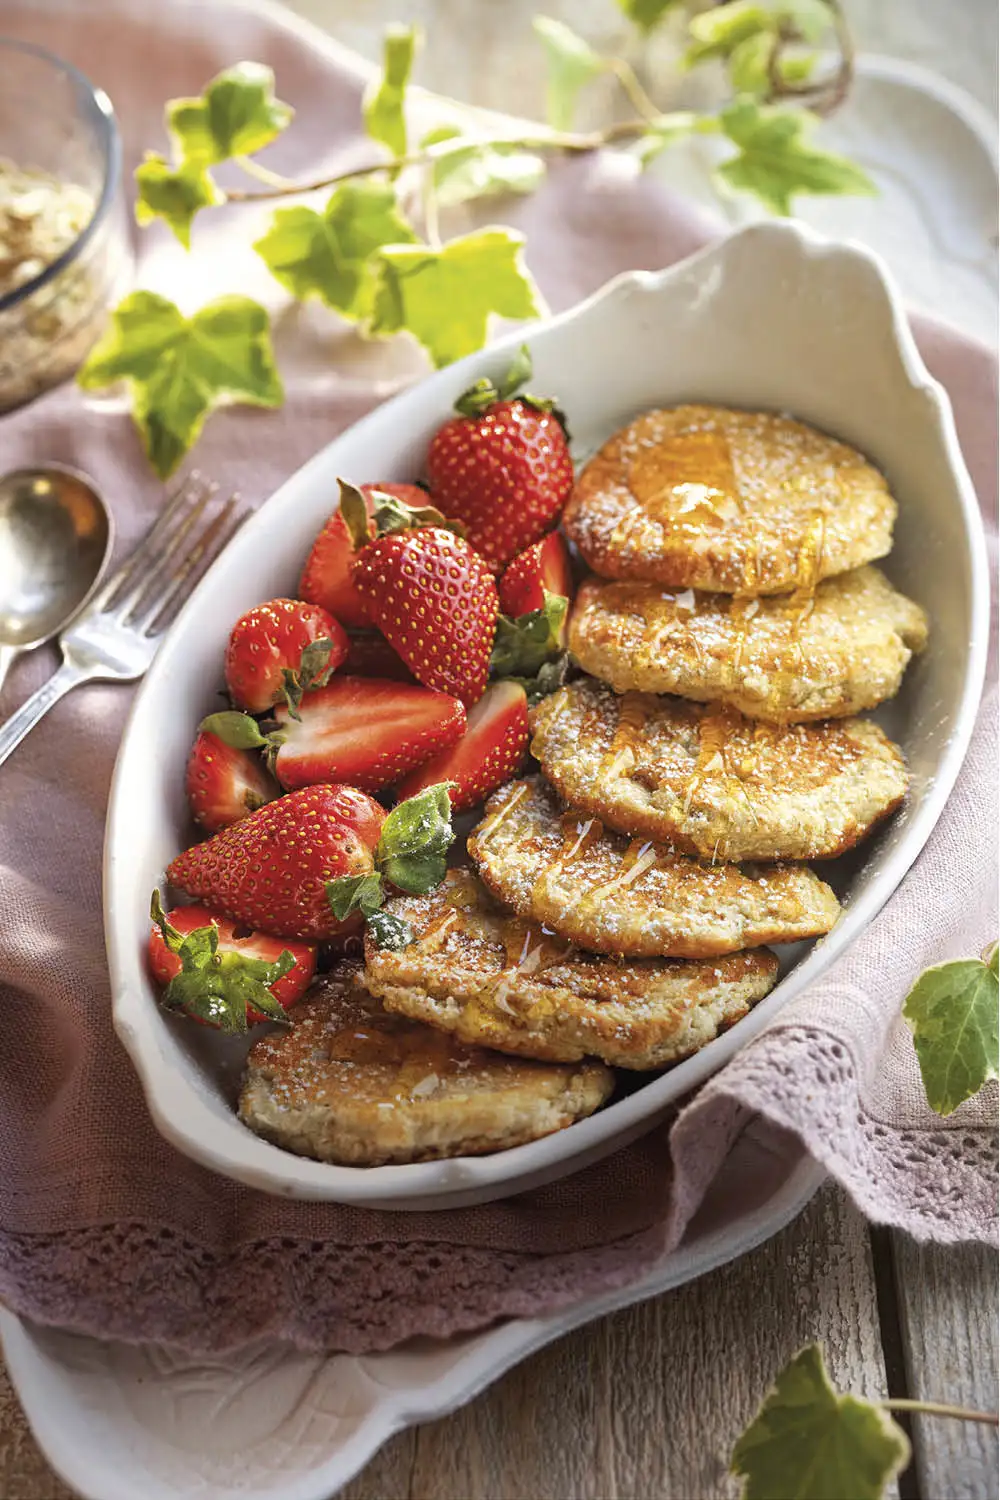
564,407,897,596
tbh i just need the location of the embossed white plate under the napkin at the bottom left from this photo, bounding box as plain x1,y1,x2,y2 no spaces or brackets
0,1125,823,1500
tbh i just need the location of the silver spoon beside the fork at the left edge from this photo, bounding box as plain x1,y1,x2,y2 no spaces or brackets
0,464,114,687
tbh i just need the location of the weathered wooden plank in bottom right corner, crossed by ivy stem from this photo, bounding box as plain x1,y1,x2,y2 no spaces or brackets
894,1235,1000,1500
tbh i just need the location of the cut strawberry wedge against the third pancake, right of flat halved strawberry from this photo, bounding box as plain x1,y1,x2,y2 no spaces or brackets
396,683,528,813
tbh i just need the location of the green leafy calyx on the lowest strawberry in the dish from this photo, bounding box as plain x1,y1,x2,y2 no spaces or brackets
150,891,295,1037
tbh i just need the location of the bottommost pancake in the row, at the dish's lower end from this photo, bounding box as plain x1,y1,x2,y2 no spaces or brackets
240,963,615,1167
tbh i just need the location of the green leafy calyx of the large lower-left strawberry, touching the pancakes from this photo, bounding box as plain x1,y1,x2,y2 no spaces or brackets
327,782,454,950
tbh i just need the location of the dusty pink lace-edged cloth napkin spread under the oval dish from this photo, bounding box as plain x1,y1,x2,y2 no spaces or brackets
0,0,997,1352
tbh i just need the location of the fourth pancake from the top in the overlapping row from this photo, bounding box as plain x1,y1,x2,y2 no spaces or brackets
469,777,840,959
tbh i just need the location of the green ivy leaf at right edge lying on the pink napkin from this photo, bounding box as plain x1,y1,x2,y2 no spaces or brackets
903,947,1000,1115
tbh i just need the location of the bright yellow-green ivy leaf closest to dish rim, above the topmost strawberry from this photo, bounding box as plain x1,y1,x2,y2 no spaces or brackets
372,228,538,368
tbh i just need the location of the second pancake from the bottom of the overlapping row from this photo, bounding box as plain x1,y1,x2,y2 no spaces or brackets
366,870,778,1070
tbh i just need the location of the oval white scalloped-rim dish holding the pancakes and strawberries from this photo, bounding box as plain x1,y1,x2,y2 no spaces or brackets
105,222,988,1209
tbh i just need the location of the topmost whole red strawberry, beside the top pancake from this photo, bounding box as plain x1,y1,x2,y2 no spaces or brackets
427,348,573,572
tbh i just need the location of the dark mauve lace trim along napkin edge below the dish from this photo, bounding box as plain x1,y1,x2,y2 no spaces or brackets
0,1223,664,1355
